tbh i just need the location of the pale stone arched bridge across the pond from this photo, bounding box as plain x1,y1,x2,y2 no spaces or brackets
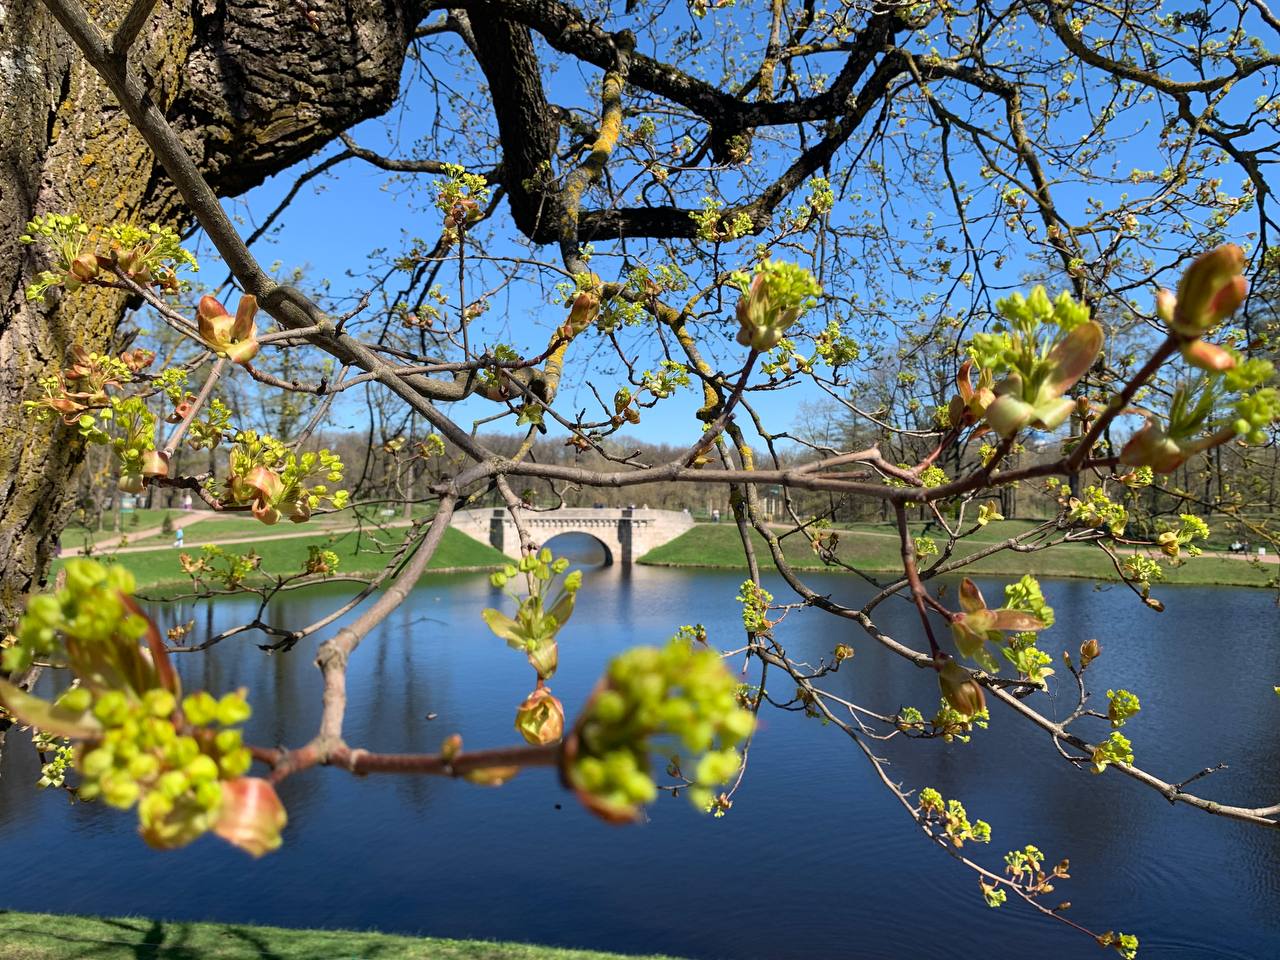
453,507,694,566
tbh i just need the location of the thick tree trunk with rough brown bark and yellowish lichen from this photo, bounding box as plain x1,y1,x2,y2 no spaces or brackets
0,0,422,627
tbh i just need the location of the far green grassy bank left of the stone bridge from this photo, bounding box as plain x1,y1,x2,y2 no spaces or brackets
54,524,507,591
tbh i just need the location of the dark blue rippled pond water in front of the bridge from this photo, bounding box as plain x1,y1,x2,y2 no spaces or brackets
0,537,1280,960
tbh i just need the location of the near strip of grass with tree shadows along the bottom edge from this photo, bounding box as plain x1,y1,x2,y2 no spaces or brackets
0,910,669,960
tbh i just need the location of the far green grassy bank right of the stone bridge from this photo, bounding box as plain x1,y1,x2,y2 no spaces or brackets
640,520,1280,586
